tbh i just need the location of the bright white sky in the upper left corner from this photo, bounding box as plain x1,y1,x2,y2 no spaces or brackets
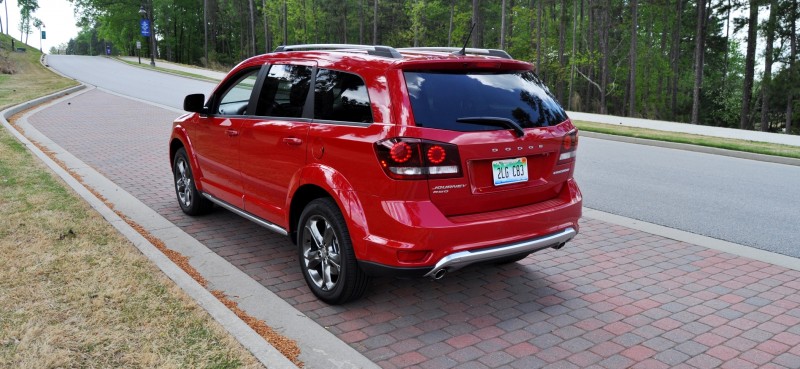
0,0,80,52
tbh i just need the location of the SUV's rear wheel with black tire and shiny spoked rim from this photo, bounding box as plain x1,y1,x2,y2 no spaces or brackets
297,198,369,305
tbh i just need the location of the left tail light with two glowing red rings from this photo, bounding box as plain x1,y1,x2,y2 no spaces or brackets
375,138,461,179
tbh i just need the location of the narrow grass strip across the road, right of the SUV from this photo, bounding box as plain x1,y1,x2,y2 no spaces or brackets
573,120,800,159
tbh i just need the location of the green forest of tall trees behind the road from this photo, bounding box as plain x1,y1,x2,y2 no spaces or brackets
6,0,800,134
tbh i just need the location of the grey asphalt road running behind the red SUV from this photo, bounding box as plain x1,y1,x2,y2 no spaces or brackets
48,55,800,257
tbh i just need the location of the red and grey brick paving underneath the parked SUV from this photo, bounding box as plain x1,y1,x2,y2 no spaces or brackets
29,90,800,368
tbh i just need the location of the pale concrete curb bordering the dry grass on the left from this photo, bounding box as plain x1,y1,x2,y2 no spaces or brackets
0,85,297,369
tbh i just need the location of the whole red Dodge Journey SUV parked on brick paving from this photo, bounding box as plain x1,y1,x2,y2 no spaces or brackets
169,45,581,304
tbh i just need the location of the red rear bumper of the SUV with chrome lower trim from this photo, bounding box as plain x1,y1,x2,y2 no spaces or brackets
353,180,582,276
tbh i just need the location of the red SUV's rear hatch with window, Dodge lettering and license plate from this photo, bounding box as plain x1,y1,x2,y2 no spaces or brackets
404,63,577,216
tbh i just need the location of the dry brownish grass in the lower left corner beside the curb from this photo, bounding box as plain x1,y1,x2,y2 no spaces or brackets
0,130,260,368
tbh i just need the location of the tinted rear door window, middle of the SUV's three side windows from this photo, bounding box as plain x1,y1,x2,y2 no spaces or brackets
256,65,312,118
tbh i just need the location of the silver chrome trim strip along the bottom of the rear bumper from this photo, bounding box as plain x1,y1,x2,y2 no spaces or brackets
425,227,578,277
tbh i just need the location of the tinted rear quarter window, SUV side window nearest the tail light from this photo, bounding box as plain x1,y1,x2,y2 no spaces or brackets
314,69,372,123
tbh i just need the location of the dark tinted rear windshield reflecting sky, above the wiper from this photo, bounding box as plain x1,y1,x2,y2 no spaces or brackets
405,71,567,131
